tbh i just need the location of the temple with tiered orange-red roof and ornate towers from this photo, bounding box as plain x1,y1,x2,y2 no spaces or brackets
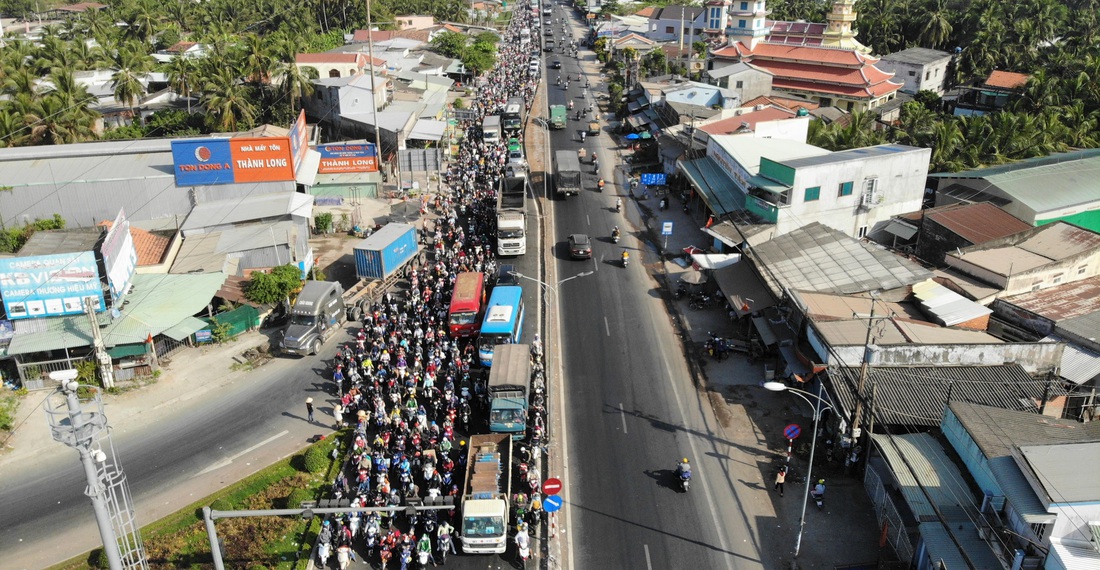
711,0,903,111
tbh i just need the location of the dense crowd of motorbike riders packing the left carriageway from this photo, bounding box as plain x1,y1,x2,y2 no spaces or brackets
308,3,547,570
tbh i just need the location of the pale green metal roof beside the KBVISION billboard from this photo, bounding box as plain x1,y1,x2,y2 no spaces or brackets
102,273,226,347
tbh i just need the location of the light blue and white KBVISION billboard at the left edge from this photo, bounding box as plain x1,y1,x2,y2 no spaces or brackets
0,251,103,320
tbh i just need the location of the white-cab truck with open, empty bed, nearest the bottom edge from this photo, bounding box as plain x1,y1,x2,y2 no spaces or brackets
459,434,512,555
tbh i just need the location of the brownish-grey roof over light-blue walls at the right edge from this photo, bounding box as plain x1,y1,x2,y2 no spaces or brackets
950,402,1100,458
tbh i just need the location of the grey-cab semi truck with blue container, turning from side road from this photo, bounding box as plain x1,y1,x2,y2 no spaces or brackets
279,223,419,357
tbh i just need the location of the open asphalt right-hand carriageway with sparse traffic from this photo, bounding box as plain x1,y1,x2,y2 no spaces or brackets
547,7,765,569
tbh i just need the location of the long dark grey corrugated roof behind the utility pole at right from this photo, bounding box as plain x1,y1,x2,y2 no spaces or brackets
829,367,1066,427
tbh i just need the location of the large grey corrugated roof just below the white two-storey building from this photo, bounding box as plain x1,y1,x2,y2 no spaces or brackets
752,222,932,294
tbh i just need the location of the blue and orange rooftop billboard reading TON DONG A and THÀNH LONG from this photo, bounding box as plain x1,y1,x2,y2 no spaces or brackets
172,136,294,186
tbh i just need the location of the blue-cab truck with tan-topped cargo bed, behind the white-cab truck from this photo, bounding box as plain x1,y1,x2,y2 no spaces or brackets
488,344,531,439
